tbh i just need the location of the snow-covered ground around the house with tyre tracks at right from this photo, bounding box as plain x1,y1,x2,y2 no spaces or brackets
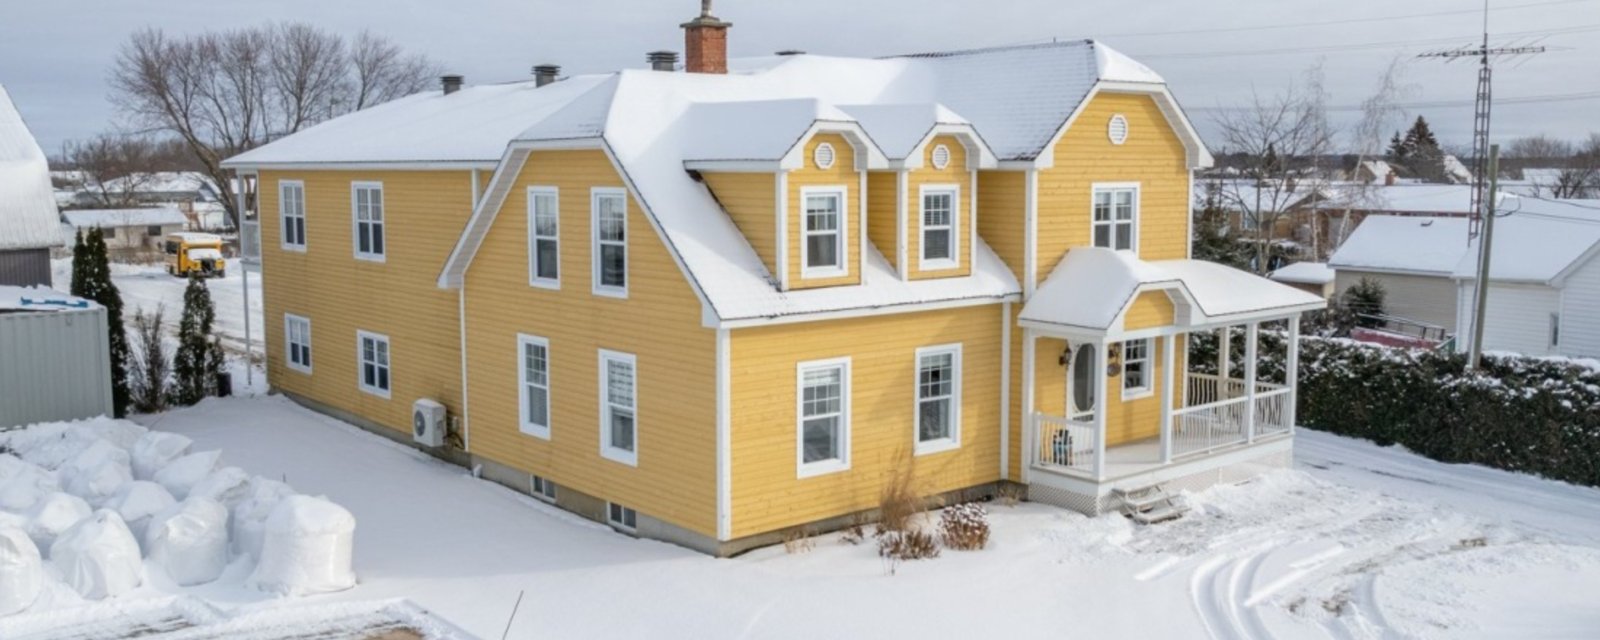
0,390,1600,638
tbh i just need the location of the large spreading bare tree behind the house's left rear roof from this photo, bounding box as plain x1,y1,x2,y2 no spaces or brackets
110,22,437,226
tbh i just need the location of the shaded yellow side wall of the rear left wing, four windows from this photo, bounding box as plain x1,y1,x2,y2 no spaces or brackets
259,171,472,432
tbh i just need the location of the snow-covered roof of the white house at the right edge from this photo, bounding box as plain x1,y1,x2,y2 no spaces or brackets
1453,197,1600,285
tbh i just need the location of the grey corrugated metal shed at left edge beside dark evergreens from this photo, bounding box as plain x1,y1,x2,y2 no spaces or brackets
0,286,112,430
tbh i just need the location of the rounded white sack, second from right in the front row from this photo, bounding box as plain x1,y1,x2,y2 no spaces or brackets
144,496,227,587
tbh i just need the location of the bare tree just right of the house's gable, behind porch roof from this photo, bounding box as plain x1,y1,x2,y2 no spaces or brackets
1216,66,1333,274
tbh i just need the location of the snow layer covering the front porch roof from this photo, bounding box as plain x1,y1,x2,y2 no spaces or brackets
1021,246,1326,333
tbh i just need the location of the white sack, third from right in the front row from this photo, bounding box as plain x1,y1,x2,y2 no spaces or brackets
50,509,144,600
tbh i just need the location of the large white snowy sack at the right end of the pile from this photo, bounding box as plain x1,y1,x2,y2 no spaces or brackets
250,496,355,595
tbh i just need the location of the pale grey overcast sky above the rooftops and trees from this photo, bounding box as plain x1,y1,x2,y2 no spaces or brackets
0,0,1600,155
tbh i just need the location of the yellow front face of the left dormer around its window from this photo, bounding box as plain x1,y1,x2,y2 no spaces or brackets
789,133,861,290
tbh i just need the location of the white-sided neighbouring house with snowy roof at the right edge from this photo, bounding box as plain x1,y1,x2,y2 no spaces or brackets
1453,198,1600,358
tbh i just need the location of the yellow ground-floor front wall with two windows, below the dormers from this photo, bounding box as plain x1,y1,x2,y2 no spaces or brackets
731,304,1000,538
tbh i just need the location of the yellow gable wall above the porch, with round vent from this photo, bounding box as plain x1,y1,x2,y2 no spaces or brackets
1036,93,1189,280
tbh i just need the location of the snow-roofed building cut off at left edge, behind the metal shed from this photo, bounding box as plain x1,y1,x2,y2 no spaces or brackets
0,86,61,286
